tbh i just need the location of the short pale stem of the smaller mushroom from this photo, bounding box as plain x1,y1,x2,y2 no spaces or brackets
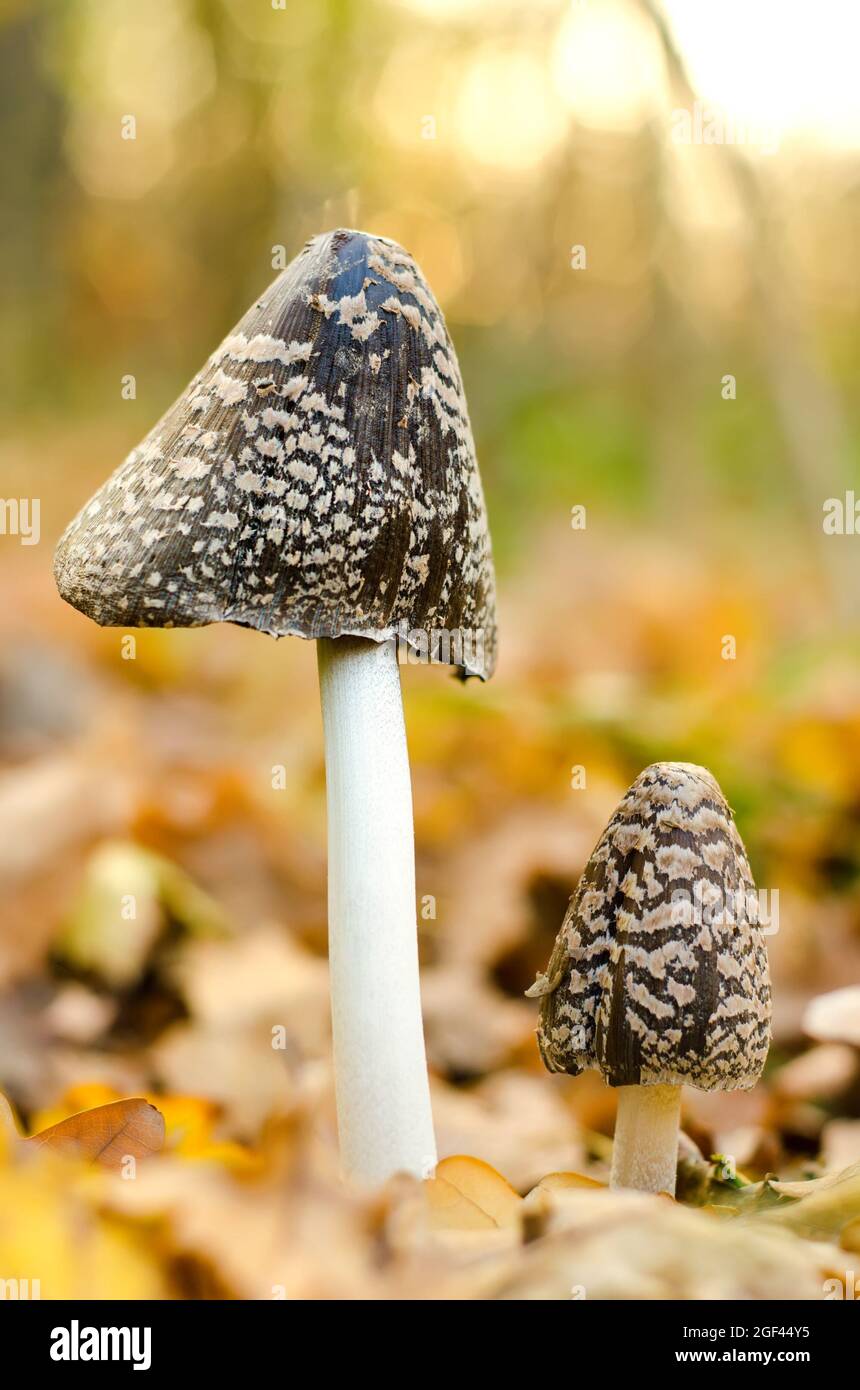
609,1086,681,1197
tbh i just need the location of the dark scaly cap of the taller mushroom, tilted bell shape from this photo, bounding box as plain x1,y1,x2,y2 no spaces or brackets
54,228,496,678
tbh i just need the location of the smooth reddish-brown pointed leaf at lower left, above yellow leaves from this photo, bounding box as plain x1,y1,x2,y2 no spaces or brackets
25,1097,164,1170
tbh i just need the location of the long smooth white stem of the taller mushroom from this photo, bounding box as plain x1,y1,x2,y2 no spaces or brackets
317,637,436,1183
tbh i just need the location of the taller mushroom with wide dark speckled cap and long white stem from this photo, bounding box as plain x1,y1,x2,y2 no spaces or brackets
54,229,496,1183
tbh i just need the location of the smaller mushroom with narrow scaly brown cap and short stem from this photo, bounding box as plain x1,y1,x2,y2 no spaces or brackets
528,763,771,1195
